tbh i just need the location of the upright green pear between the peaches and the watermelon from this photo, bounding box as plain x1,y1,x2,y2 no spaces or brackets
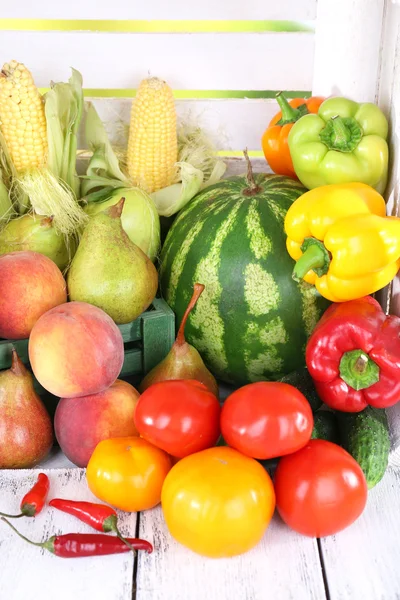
67,198,158,324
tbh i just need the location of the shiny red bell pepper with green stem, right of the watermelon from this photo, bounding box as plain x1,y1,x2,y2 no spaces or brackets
306,296,400,412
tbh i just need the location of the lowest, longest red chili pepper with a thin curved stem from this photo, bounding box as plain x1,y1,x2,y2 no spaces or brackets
1,517,153,558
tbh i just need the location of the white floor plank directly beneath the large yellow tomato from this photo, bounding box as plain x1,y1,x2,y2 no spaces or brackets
136,507,325,600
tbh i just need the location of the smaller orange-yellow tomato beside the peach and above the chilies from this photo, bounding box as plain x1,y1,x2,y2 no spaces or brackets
86,437,171,512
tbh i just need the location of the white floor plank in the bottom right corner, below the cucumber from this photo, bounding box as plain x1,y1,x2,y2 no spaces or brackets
321,471,400,600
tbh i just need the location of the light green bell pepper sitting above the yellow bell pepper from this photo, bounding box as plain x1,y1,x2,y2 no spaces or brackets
288,97,389,194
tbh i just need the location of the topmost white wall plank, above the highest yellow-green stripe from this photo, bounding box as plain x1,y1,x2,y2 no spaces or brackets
1,0,317,20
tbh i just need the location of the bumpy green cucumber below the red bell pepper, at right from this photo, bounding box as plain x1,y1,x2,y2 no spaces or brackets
337,406,390,490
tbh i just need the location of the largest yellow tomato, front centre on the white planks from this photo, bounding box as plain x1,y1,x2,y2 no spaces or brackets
161,447,275,558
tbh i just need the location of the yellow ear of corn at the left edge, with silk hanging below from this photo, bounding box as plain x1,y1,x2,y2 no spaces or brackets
0,60,47,173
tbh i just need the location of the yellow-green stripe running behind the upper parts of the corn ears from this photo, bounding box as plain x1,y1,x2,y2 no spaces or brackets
39,88,311,100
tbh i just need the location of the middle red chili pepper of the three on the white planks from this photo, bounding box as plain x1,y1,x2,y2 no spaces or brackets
49,498,134,545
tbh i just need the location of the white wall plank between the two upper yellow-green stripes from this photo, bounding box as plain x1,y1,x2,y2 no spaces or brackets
0,31,314,90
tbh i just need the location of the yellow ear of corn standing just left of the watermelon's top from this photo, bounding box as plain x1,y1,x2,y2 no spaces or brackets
127,77,178,193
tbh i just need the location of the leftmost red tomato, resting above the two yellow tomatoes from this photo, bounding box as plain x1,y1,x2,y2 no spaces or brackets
135,379,221,458
